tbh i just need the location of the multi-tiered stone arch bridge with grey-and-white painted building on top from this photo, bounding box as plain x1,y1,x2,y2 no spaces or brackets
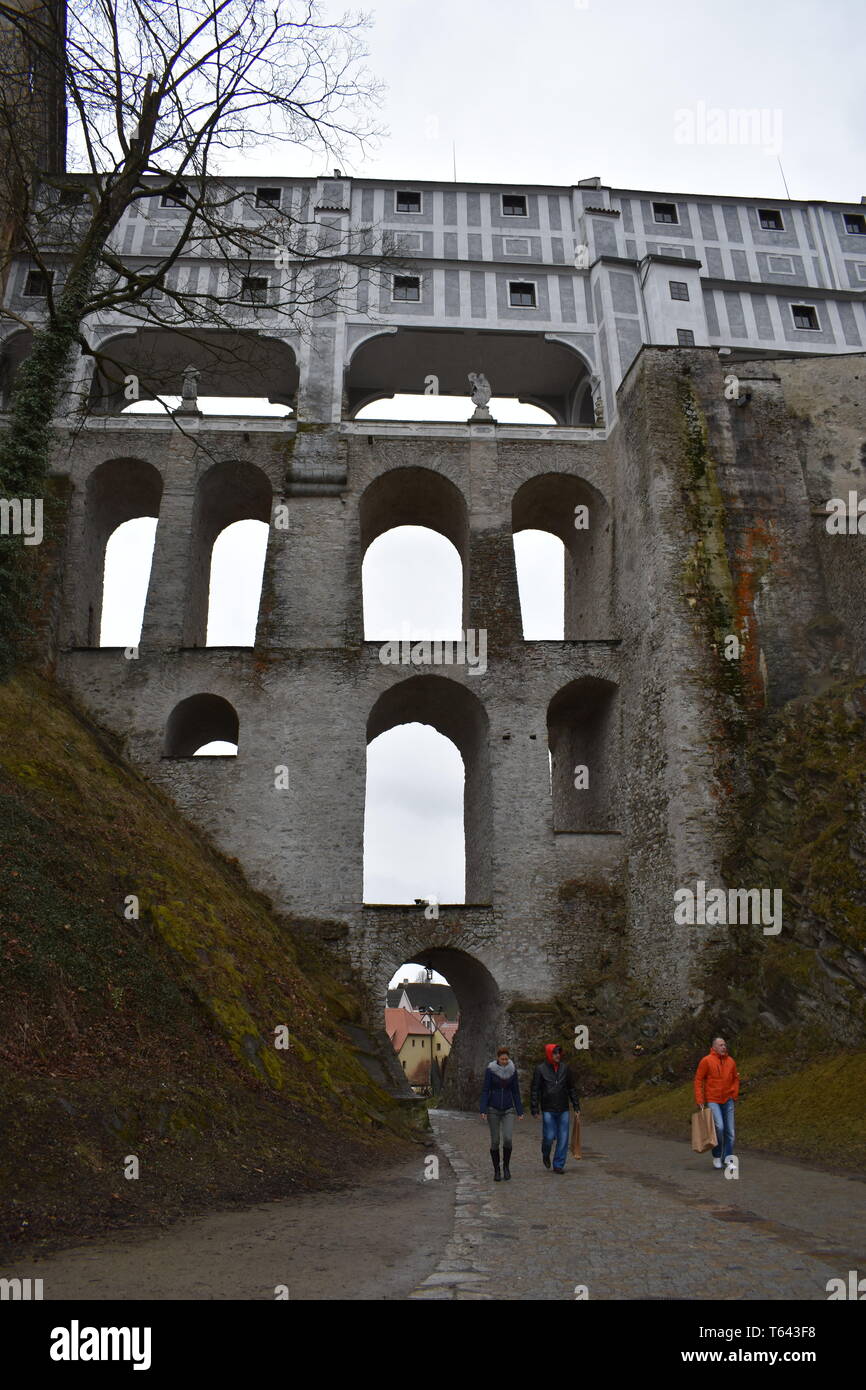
4,178,866,1105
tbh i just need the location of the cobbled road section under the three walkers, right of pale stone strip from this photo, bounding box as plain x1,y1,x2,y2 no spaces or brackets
411,1111,866,1301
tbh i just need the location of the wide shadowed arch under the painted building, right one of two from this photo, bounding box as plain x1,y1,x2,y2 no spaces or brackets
343,328,592,425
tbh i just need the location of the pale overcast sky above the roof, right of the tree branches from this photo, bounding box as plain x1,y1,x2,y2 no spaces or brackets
237,0,866,202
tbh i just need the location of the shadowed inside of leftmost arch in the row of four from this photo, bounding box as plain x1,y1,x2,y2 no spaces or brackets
75,457,163,646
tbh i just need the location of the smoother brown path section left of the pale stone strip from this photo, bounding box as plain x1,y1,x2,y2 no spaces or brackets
0,1145,455,1301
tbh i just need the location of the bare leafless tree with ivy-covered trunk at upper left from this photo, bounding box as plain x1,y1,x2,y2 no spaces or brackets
0,0,392,674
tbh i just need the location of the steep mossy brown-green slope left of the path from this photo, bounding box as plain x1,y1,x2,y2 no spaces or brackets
0,674,419,1250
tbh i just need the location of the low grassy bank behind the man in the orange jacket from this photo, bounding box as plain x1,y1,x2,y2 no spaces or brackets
585,1052,866,1173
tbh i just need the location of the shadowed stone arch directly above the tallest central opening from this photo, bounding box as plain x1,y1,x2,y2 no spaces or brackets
359,467,470,635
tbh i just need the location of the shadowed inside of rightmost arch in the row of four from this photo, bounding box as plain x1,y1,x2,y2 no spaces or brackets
512,473,613,641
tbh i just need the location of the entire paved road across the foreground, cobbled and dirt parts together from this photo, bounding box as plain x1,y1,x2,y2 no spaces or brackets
0,1111,866,1301
